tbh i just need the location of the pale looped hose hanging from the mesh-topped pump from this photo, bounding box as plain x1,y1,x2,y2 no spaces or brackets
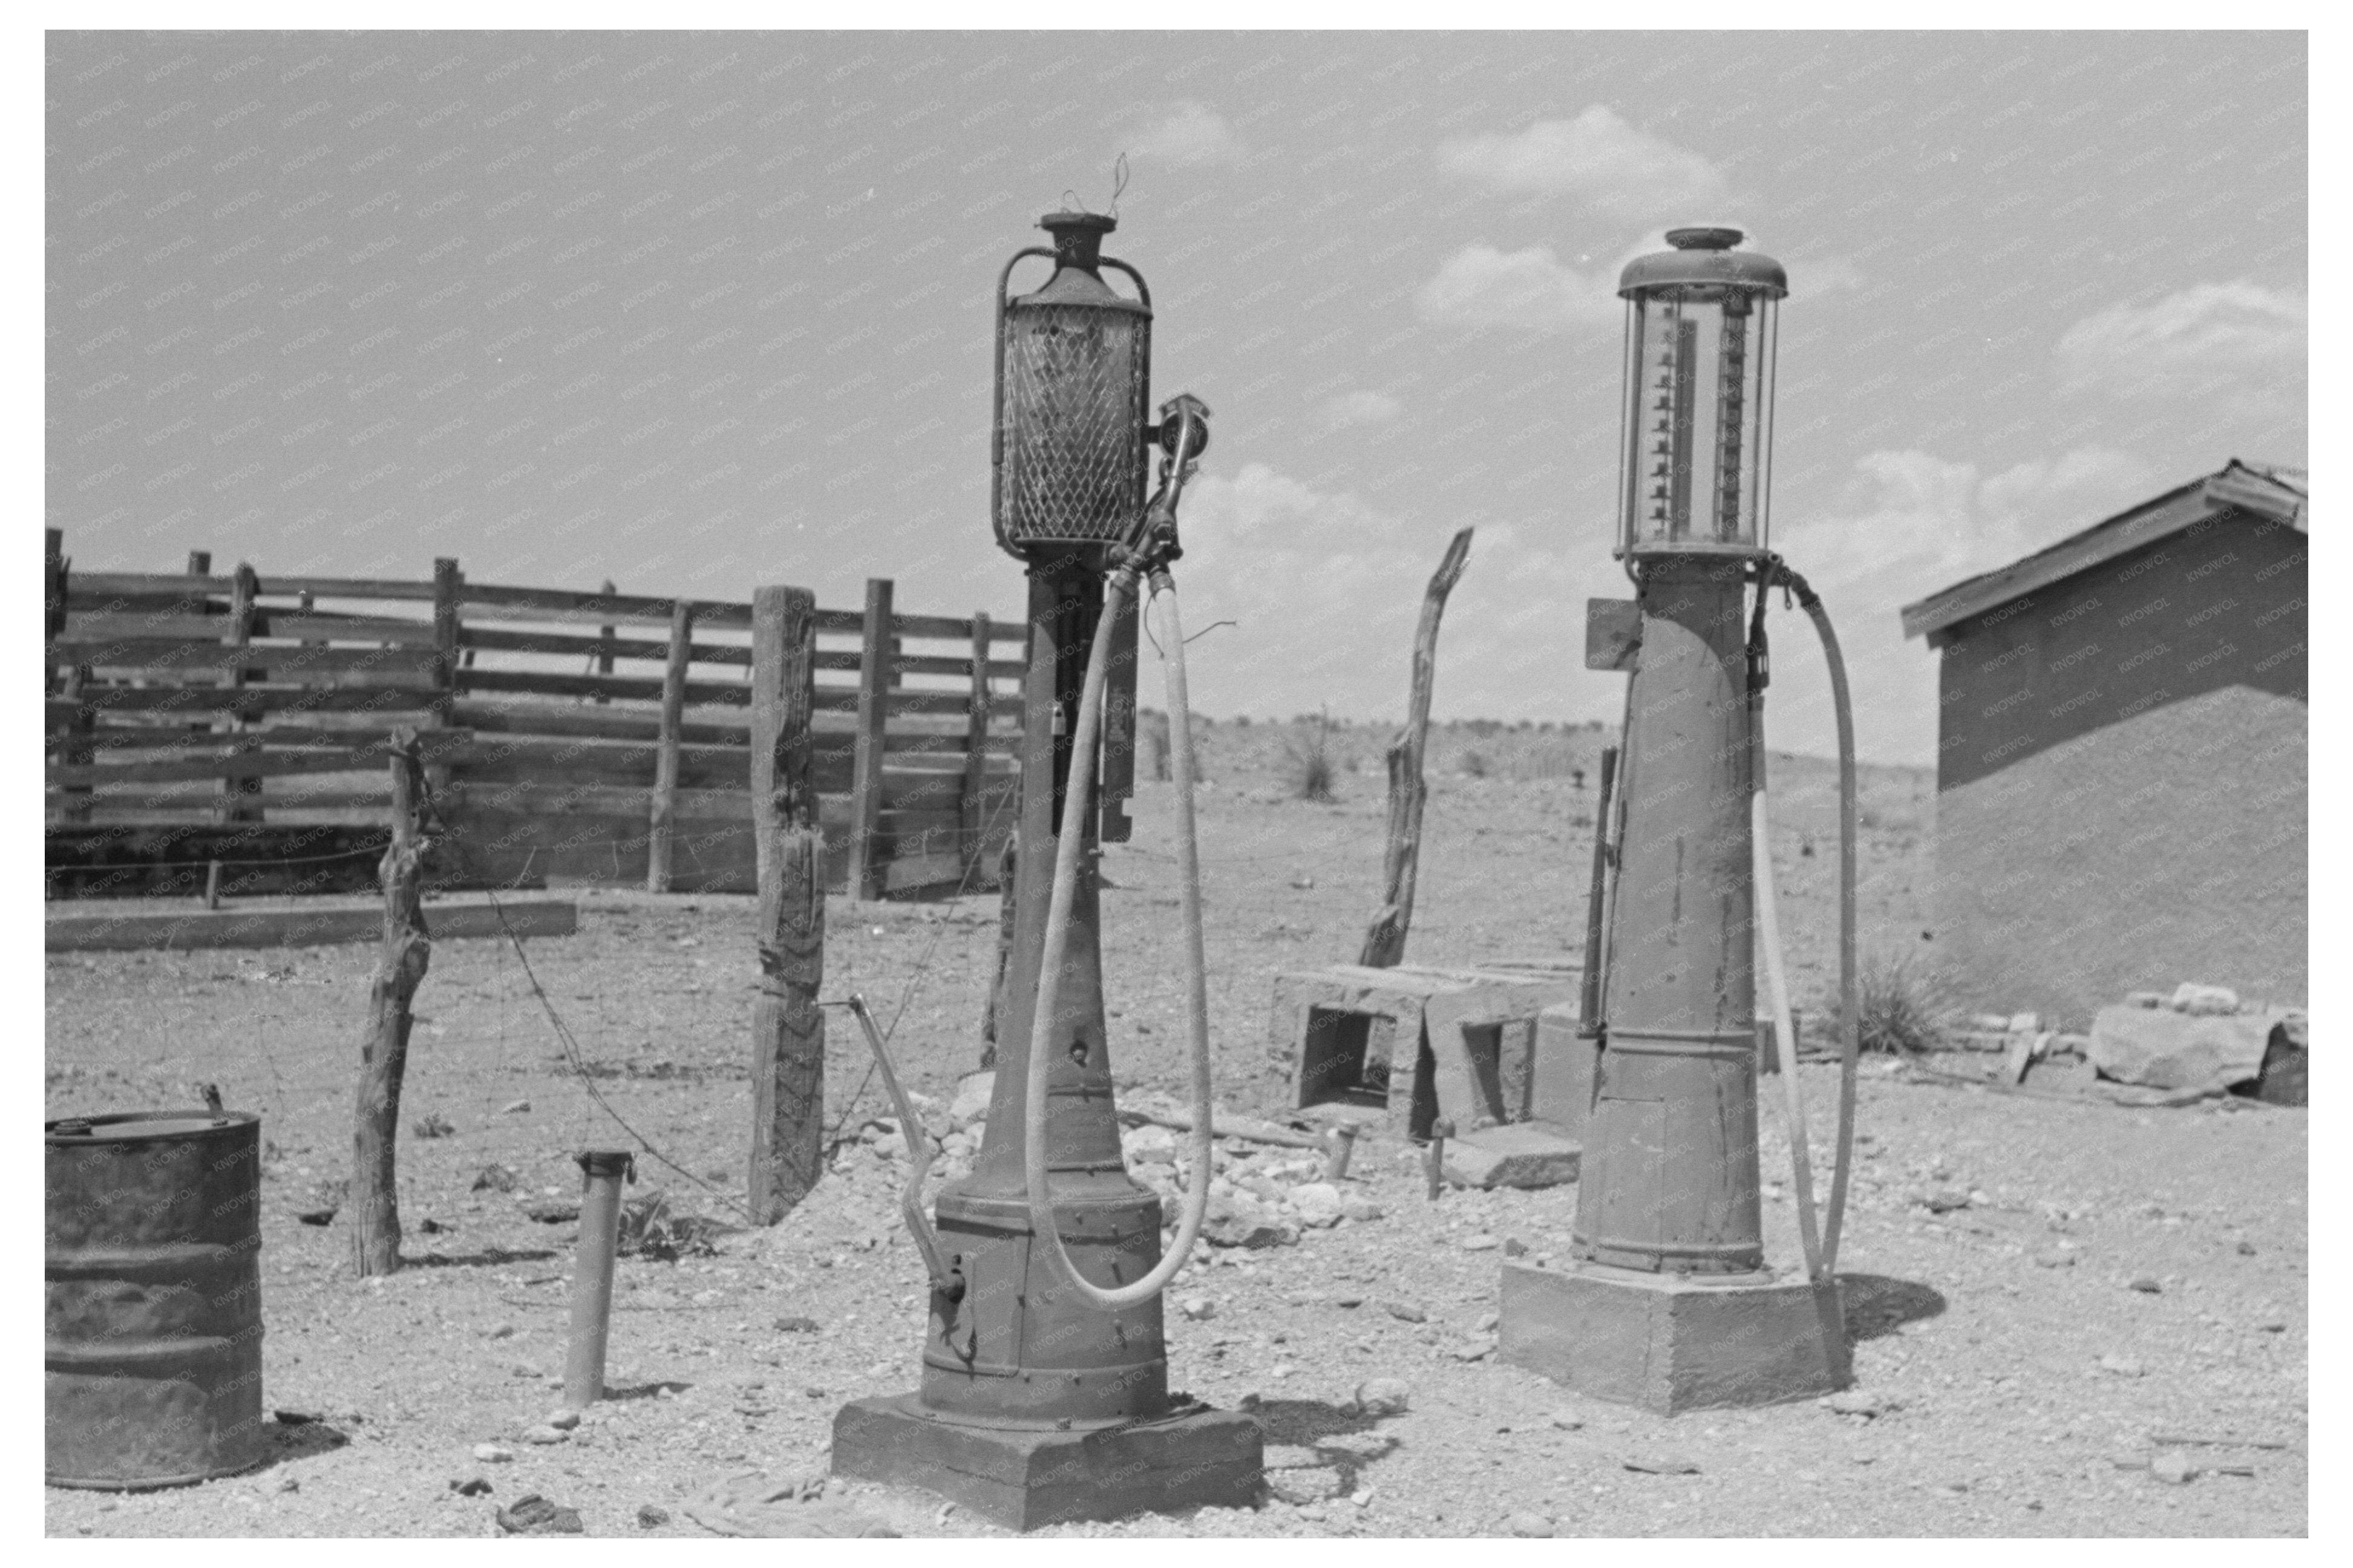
1021,572,1217,1309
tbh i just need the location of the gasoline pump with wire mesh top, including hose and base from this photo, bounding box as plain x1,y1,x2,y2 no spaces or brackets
833,212,1262,1530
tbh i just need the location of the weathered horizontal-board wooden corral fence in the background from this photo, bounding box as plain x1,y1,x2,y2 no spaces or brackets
45,530,1026,897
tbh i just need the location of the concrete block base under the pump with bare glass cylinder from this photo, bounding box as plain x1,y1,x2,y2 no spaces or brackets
1496,1262,1854,1415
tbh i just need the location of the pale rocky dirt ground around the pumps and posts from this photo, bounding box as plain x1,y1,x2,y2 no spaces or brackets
45,723,2308,1537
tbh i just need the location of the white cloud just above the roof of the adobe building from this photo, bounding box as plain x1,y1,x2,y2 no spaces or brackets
2057,283,2308,414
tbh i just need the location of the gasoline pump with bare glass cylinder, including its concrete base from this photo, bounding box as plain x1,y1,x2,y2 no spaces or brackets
1501,229,1854,1413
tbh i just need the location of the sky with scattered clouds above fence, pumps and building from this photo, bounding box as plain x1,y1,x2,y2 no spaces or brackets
45,33,2308,765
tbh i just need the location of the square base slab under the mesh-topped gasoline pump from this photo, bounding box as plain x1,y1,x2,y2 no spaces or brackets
833,1394,1263,1530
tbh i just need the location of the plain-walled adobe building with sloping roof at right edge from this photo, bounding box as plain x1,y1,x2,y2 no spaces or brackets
1903,459,2308,1029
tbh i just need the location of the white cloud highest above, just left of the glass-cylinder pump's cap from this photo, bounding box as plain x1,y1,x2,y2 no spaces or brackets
1438,103,1725,221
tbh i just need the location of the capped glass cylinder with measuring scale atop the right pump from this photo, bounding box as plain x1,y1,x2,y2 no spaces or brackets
1617,229,1788,555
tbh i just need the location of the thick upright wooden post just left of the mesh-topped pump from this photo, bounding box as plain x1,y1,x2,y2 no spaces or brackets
746,586,833,1224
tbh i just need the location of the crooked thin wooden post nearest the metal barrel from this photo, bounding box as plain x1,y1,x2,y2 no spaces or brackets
346,730,433,1278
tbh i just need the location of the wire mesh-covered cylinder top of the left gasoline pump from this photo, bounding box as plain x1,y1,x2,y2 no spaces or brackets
995,212,1153,555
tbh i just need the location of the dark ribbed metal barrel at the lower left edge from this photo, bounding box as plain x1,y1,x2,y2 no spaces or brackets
45,1111,266,1488
